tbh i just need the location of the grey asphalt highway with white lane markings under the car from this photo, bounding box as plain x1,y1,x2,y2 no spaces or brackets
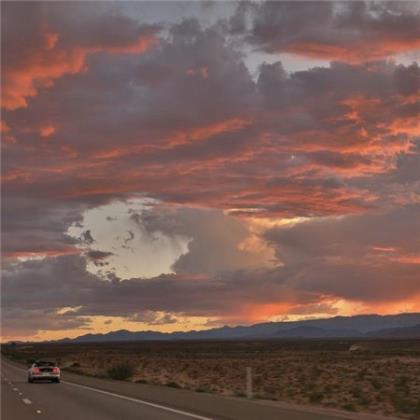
1,359,380,420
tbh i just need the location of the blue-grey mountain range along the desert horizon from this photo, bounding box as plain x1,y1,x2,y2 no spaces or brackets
59,313,420,343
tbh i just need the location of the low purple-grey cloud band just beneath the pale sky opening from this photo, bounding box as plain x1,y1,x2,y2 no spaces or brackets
3,256,302,328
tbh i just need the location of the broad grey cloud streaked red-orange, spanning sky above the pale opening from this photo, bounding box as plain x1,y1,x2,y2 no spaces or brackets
4,55,419,216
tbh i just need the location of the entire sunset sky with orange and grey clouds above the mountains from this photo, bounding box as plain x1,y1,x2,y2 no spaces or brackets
1,1,420,340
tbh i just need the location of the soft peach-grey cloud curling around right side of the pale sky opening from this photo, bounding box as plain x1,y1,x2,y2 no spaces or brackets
135,205,272,275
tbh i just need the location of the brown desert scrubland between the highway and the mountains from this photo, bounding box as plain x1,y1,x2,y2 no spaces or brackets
2,340,420,419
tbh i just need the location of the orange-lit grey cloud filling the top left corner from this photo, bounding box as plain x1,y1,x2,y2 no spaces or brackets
2,3,157,110
